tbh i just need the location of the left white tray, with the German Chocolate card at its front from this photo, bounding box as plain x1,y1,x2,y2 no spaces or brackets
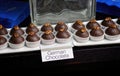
0,25,73,54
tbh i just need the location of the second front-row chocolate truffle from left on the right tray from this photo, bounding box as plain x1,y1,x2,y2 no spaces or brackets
90,27,104,37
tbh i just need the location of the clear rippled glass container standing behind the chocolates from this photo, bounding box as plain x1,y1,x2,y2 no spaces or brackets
29,0,96,25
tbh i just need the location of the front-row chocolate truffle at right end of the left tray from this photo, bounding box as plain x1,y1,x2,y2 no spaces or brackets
56,29,70,38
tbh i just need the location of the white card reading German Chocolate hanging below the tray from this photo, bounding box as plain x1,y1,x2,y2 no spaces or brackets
41,48,74,62
